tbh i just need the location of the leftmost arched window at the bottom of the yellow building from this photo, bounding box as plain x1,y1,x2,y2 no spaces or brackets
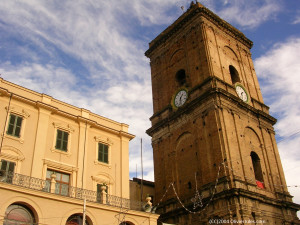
3,204,36,225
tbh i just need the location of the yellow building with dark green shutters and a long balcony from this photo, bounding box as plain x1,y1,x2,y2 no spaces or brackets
0,79,158,225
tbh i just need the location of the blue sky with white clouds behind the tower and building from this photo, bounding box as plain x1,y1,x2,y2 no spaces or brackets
0,0,300,210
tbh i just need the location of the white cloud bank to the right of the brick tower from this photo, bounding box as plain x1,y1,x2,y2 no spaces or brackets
255,38,300,207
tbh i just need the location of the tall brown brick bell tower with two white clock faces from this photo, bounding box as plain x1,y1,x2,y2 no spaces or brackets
145,2,300,225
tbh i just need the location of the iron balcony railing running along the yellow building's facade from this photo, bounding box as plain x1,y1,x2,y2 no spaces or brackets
0,170,144,211
